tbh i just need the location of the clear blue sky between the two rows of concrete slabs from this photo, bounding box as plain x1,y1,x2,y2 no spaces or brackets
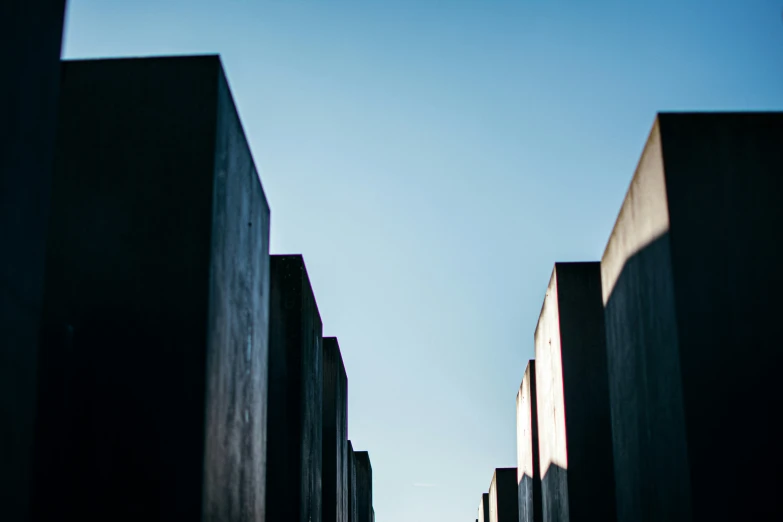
64,0,783,522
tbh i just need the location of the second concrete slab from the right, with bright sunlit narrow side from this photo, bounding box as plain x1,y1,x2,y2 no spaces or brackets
535,262,616,522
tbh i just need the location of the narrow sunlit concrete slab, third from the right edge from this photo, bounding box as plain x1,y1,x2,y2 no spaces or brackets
517,360,543,522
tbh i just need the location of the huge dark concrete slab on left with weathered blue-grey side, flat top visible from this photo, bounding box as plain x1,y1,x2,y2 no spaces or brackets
34,56,270,521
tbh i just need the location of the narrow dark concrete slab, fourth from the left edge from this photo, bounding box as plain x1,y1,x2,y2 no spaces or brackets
321,337,348,522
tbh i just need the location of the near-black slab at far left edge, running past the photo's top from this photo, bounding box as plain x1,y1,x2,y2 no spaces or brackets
0,0,65,522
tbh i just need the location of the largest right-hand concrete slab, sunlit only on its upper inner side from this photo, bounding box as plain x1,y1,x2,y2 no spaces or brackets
601,113,783,522
